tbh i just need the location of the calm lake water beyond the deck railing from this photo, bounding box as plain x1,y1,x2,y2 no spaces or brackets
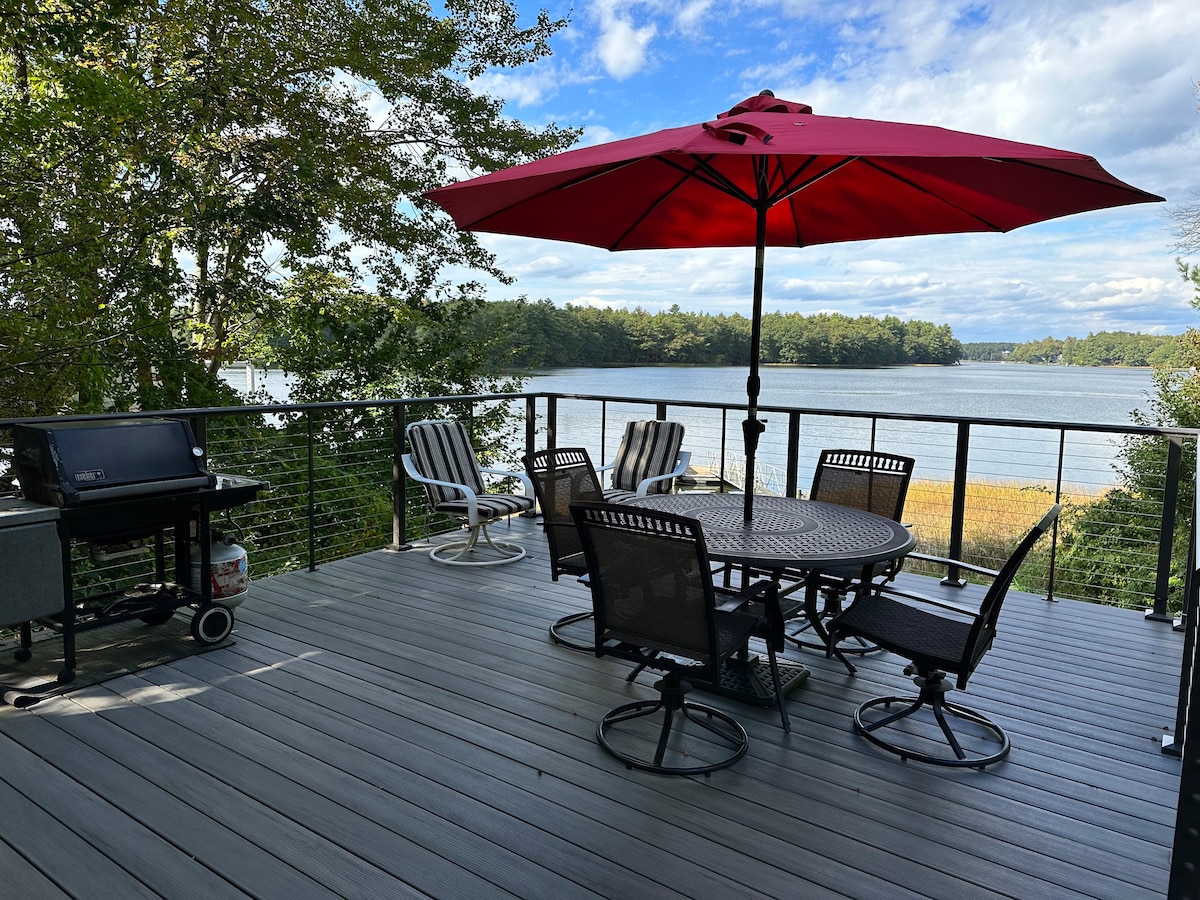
227,362,1154,492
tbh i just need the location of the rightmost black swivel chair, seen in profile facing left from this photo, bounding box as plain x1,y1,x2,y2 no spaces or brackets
829,504,1062,769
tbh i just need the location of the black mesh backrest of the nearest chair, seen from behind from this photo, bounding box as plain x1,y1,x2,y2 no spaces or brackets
571,503,719,679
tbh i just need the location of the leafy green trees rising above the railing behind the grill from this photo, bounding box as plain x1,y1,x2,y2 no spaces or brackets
0,0,574,415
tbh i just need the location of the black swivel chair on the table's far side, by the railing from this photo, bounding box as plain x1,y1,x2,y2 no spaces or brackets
787,450,916,654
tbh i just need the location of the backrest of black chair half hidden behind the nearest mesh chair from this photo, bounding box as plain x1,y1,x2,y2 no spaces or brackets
522,446,602,581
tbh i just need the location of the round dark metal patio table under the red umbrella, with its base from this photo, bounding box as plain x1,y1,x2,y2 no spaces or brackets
630,492,917,703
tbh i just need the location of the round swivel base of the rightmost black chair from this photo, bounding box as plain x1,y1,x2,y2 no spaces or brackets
854,676,1013,769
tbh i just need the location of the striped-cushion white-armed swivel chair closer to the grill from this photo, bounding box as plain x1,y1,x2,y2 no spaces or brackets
402,420,534,565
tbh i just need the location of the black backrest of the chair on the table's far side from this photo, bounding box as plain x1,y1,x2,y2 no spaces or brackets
809,450,916,522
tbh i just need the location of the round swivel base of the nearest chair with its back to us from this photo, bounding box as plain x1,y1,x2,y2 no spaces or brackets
596,676,750,776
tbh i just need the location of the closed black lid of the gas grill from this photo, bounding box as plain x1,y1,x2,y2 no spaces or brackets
12,419,216,506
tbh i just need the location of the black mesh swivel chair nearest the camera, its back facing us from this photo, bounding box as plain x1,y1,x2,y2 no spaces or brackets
571,503,791,775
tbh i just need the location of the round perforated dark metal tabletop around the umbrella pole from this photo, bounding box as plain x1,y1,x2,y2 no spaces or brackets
636,493,916,569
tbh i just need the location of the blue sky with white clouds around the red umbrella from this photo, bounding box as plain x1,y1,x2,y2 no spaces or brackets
448,0,1200,341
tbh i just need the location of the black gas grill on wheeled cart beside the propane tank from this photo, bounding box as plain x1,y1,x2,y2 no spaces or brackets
12,418,266,683
